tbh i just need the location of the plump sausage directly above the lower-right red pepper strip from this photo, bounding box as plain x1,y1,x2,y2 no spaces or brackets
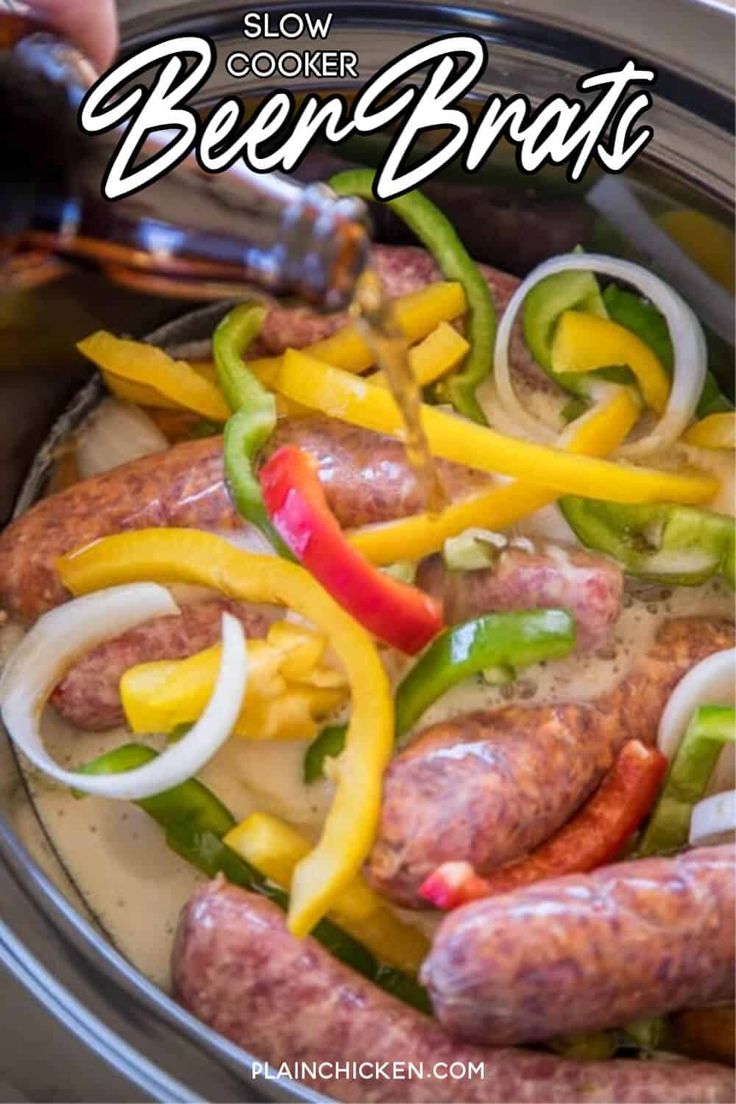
366,617,733,907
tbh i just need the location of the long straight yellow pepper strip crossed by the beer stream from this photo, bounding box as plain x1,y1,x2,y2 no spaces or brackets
276,350,718,505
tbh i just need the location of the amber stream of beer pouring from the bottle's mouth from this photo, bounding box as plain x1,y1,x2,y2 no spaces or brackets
351,269,447,514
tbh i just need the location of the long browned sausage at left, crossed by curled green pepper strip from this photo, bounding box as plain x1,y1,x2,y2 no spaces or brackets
0,417,486,622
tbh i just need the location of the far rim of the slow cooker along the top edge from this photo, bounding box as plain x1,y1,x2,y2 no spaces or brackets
115,0,736,126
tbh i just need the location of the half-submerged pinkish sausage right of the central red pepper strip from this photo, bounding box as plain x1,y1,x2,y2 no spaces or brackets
416,548,623,651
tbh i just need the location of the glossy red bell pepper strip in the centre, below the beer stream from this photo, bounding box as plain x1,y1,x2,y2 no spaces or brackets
260,445,442,656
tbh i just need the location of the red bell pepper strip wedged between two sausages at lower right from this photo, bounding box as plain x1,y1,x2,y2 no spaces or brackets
419,740,668,910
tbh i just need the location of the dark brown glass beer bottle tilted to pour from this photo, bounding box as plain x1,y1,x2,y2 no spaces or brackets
0,22,370,310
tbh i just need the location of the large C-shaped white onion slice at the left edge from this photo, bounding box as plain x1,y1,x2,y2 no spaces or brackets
0,583,247,800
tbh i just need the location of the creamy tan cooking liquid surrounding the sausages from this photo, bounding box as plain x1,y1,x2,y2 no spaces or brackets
0,582,734,989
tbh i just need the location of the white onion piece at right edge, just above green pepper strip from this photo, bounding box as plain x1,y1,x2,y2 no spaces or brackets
657,648,736,793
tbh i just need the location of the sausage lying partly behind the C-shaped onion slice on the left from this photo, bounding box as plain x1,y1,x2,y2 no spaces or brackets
51,598,273,731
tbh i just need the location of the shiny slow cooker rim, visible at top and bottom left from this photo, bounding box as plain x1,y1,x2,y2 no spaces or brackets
0,0,734,1102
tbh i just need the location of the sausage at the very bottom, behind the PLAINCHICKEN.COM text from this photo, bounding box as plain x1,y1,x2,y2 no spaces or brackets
172,881,734,1104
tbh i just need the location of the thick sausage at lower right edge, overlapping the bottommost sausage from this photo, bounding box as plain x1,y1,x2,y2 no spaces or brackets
422,845,736,1047
